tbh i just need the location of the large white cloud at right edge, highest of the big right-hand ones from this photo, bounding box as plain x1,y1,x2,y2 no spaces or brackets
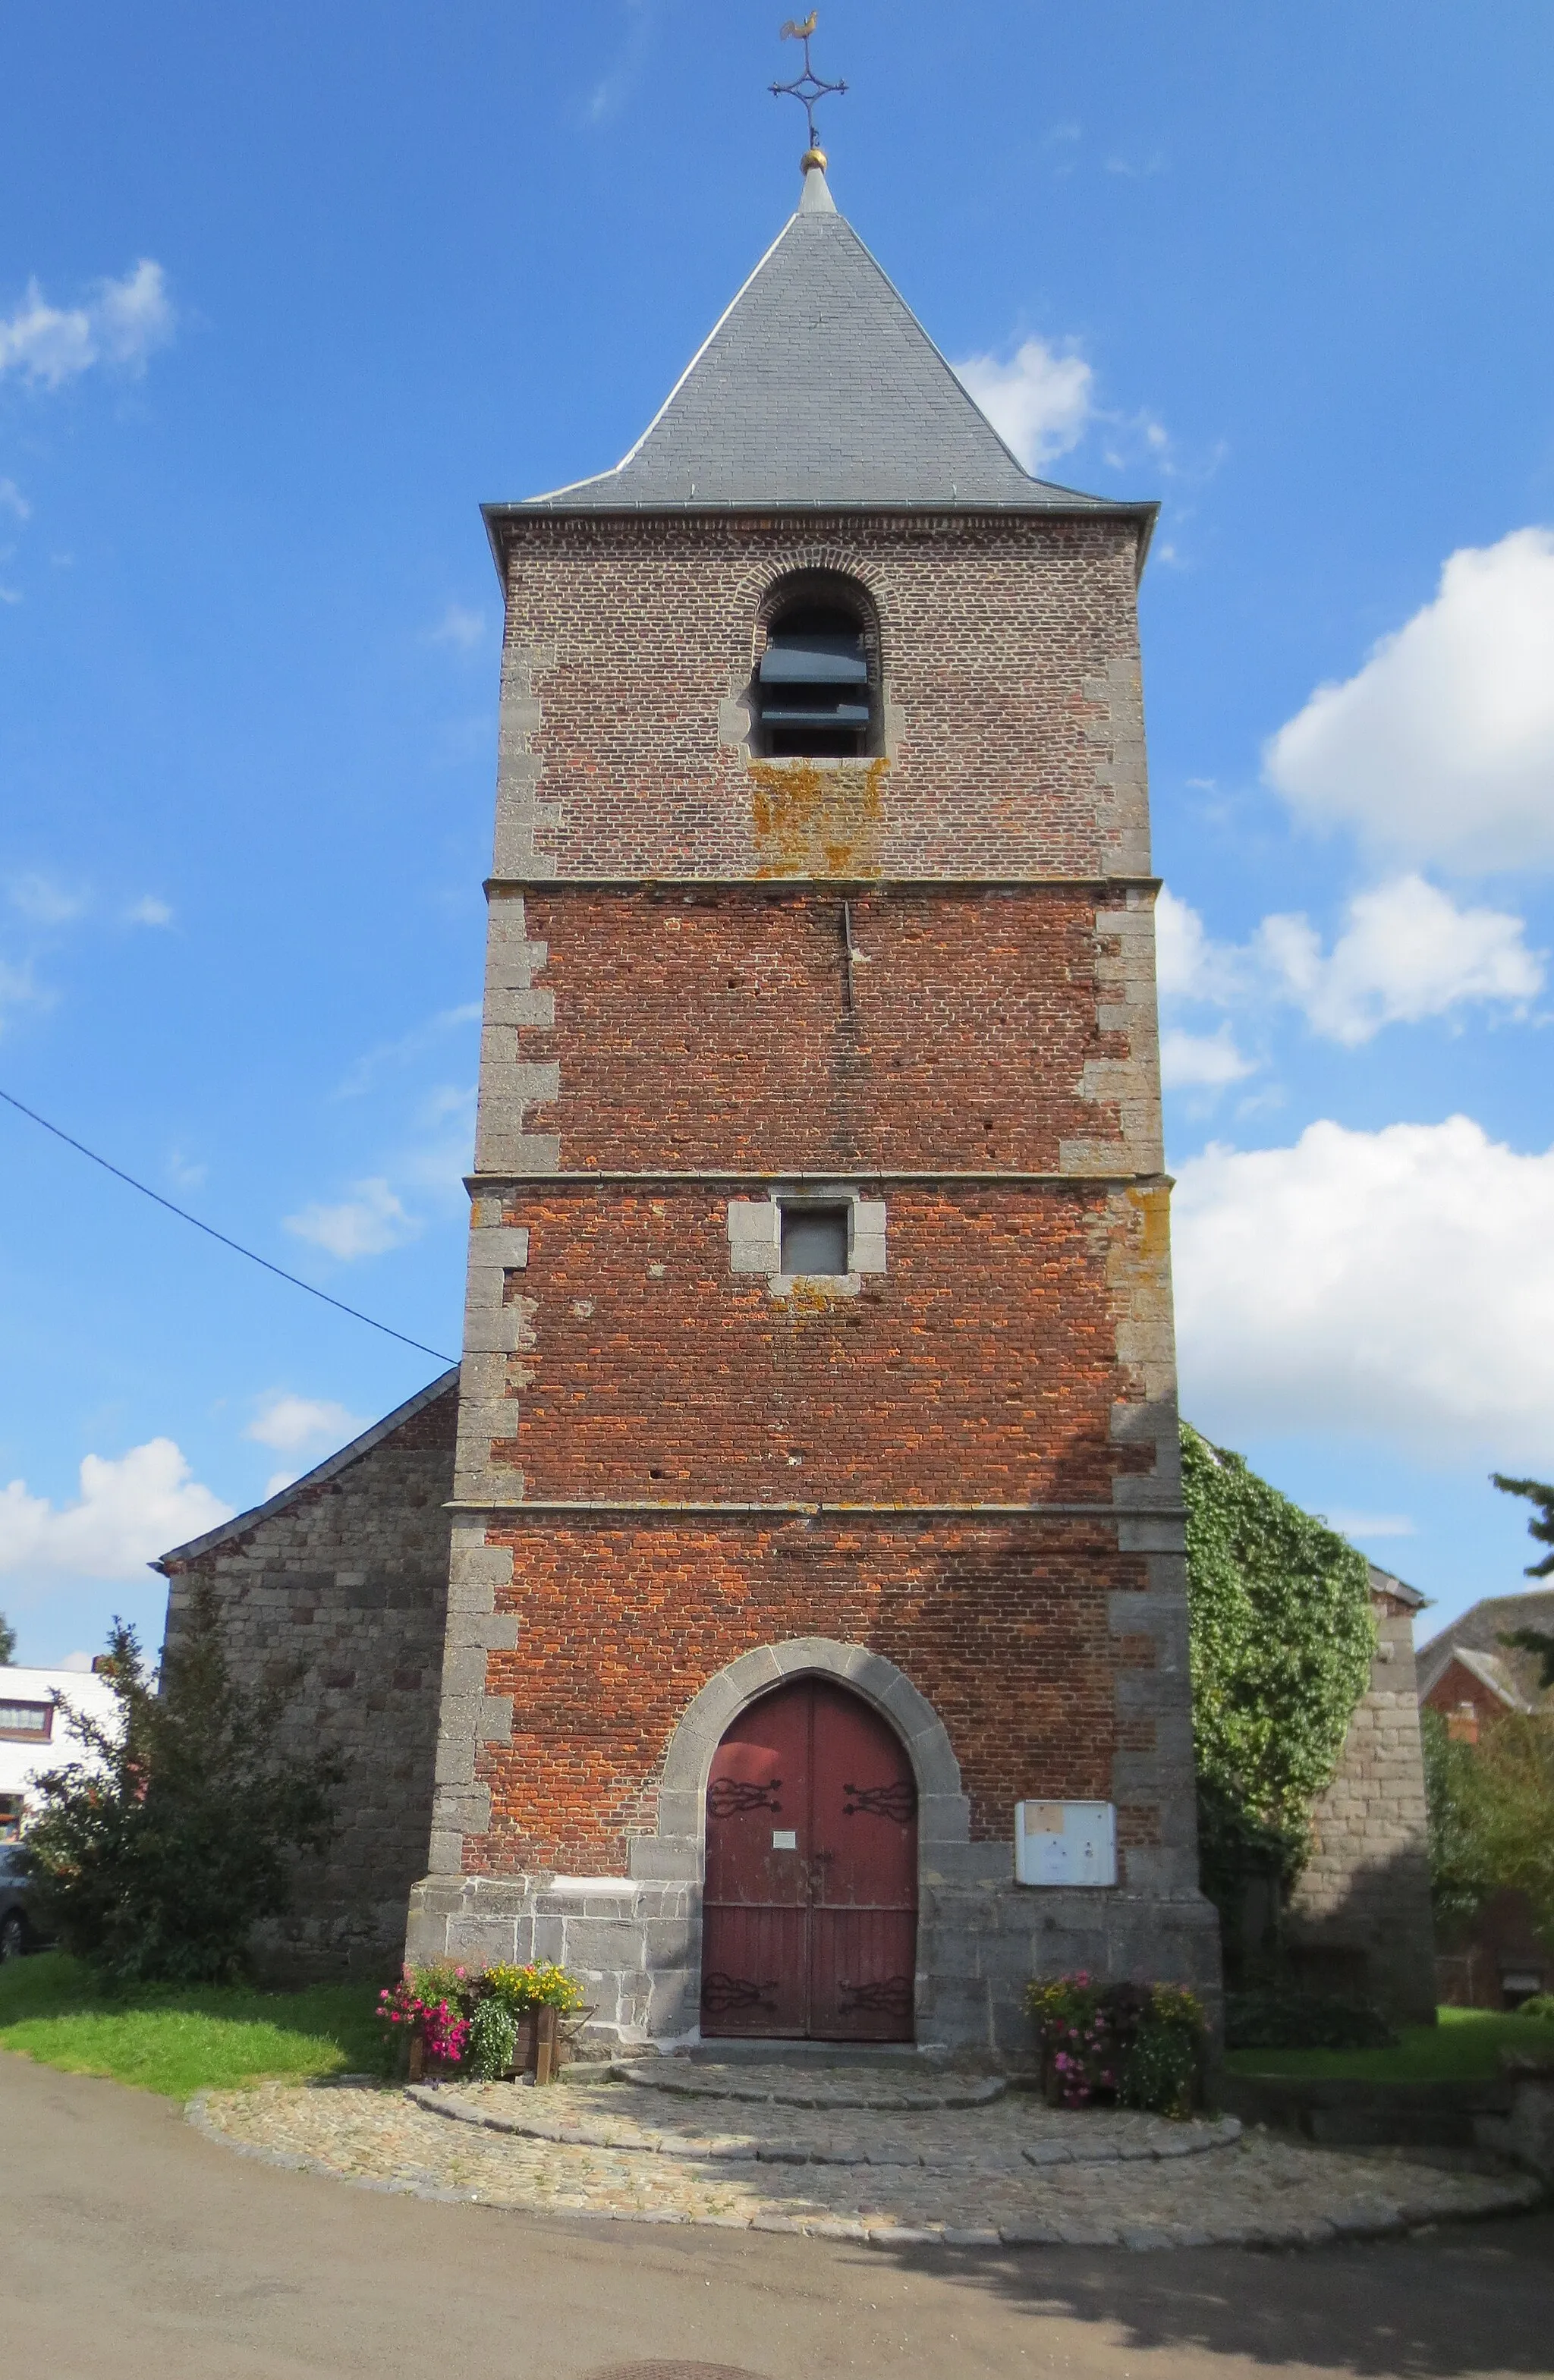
1263,528,1554,871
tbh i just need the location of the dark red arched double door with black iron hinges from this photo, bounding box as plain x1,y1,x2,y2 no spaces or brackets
702,1678,916,2042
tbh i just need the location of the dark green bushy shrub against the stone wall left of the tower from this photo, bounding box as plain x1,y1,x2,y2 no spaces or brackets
26,1580,343,1982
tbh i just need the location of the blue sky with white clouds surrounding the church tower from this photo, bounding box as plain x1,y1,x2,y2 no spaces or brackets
0,0,1554,1662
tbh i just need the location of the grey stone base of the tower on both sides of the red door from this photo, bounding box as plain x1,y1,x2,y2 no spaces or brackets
407,1842,1219,2061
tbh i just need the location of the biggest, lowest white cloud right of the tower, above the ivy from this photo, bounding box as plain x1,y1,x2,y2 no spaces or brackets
1173,1116,1554,1478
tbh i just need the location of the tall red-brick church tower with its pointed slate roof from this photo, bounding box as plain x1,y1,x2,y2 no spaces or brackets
409,152,1219,2047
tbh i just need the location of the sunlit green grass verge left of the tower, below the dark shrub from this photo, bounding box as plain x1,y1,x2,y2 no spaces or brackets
0,1951,379,2099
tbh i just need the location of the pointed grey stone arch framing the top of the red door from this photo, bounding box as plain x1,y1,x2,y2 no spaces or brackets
631,1637,971,1880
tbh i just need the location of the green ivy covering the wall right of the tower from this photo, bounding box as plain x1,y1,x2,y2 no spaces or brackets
1183,1423,1376,1897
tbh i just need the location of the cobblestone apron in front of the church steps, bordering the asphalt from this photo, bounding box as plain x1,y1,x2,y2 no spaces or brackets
188,2083,1540,2246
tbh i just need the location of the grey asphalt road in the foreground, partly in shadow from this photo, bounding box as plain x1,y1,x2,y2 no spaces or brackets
0,2054,1554,2380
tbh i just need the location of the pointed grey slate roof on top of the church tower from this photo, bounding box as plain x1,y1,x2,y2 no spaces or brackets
486,167,1156,531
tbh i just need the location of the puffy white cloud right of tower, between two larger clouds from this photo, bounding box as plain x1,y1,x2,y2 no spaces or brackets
1156,876,1544,1047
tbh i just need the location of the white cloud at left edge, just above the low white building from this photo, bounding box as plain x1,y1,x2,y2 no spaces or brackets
0,1438,233,1578
